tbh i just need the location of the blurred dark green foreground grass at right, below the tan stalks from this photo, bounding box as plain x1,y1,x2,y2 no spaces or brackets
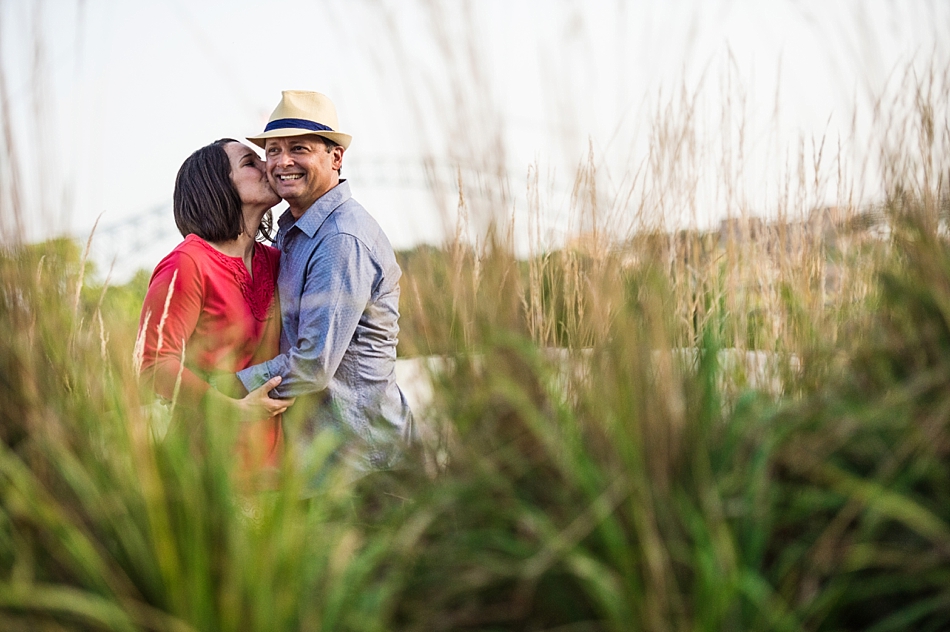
380,210,950,630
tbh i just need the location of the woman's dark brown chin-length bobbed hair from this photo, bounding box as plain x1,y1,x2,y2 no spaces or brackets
173,138,272,242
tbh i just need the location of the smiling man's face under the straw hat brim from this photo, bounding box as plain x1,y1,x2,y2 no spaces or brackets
264,135,343,218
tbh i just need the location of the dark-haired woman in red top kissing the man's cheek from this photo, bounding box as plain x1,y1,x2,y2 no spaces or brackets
137,138,293,473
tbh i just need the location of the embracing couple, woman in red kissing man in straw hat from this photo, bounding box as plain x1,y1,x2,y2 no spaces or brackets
139,91,413,484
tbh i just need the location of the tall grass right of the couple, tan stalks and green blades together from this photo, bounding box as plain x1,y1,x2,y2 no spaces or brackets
382,63,950,630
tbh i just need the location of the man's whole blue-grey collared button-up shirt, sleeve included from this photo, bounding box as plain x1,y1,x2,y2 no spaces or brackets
238,180,413,468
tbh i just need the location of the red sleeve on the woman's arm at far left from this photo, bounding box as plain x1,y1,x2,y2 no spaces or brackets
139,252,210,408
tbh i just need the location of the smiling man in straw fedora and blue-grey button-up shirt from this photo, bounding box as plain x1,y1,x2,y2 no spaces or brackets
238,90,413,469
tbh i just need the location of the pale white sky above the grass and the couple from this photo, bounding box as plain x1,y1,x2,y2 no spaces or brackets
0,0,950,277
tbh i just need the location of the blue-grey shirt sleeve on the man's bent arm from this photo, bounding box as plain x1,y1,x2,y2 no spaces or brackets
237,234,379,397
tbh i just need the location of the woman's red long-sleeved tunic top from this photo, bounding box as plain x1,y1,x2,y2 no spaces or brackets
139,235,281,472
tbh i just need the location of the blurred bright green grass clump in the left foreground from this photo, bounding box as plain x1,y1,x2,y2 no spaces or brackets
0,242,416,630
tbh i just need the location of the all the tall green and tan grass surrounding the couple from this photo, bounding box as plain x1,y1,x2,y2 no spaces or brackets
0,8,950,631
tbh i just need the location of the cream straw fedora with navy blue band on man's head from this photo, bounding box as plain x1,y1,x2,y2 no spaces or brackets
247,90,353,149
